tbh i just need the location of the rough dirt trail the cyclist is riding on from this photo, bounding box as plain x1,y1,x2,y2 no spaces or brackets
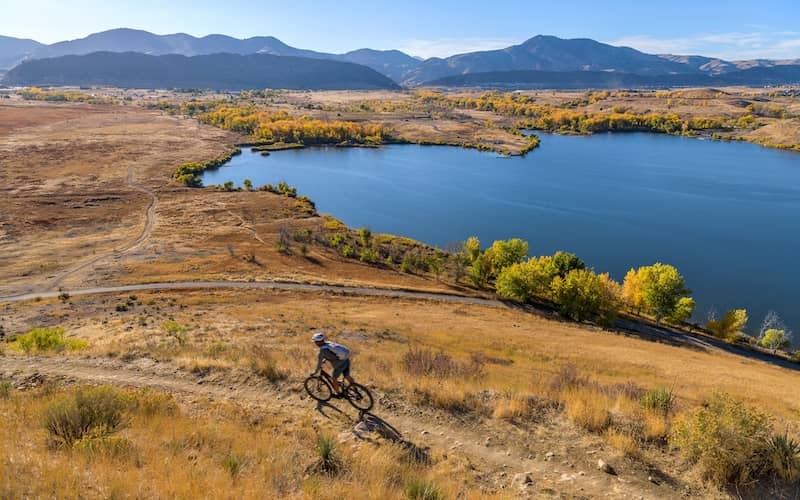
0,356,678,499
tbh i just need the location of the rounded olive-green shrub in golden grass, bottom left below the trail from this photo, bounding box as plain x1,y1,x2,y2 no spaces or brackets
44,386,130,446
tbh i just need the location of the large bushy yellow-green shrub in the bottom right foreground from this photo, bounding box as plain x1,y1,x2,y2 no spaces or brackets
670,393,772,486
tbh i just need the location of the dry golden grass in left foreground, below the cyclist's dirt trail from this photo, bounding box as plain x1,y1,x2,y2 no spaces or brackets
0,382,506,499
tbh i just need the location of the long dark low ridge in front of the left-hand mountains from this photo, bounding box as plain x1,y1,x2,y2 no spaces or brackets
3,52,400,90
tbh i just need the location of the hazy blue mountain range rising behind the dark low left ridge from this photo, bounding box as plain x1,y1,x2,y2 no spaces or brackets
0,28,800,88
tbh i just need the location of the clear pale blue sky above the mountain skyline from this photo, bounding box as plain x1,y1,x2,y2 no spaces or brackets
6,0,800,59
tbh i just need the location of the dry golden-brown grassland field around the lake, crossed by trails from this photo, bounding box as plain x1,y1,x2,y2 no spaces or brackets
0,89,800,498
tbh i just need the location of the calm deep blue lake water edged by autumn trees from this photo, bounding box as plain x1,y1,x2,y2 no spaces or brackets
203,134,800,338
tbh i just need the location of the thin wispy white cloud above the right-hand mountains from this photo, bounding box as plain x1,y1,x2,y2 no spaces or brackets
606,31,800,60
